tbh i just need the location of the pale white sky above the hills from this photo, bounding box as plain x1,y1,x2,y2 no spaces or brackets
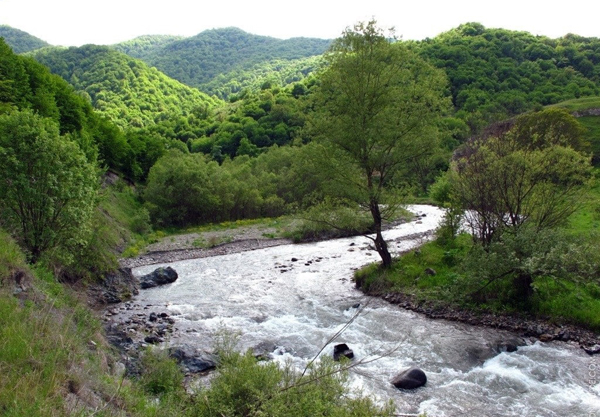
0,0,600,46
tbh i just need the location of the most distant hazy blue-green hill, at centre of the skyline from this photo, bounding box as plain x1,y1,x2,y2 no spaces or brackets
113,28,331,93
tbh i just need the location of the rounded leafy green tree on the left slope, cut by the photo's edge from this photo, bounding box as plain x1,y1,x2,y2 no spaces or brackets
0,111,98,262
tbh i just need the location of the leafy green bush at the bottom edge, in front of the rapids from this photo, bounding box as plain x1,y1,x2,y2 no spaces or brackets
196,352,393,417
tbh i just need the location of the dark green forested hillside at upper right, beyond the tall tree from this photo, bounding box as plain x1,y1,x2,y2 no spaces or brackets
411,23,600,132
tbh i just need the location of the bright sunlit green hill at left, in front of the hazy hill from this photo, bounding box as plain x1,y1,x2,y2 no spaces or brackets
33,45,217,128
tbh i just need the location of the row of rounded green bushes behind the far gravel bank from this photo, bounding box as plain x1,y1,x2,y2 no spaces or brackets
144,144,331,226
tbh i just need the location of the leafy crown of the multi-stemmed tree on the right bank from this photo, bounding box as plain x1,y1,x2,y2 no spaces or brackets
450,109,591,245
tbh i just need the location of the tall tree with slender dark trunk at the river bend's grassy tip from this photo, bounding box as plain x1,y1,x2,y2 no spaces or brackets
314,21,446,267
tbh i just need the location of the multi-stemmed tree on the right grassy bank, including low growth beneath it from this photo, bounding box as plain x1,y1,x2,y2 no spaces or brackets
449,114,592,305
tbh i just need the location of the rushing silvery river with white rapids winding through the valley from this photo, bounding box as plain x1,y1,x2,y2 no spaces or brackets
134,206,600,417
